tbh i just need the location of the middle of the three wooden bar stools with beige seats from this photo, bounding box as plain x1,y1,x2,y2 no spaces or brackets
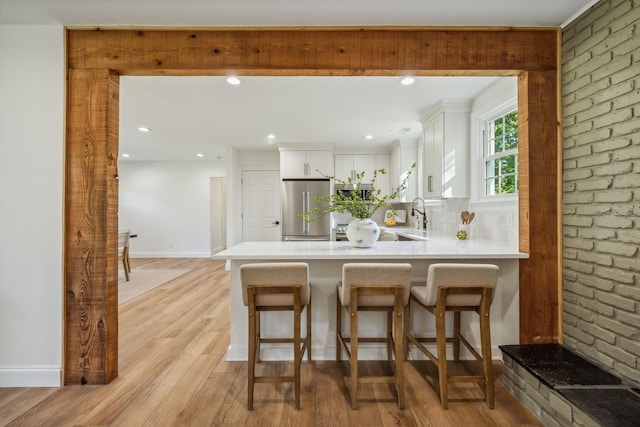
336,263,411,409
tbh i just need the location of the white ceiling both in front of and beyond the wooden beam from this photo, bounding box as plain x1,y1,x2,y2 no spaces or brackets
0,0,597,160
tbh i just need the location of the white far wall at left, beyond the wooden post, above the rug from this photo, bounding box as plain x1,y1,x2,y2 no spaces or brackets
118,160,226,258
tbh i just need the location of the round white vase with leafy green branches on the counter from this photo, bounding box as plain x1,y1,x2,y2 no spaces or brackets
301,163,416,248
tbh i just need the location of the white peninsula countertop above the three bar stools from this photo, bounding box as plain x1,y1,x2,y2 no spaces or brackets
213,237,529,260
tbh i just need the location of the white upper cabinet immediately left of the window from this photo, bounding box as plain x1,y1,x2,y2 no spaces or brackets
421,99,471,198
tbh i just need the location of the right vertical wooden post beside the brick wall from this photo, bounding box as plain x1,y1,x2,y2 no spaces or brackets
518,71,561,344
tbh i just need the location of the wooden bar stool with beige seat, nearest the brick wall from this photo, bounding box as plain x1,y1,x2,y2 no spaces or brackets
404,263,498,409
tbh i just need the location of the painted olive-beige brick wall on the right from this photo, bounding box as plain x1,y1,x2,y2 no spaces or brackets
562,0,640,384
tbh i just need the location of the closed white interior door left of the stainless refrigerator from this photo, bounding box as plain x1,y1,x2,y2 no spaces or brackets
242,171,282,242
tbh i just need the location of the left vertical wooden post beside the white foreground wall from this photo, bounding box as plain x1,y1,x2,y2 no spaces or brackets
64,69,119,384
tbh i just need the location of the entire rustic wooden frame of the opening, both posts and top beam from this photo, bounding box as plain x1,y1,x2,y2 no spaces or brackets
64,28,561,384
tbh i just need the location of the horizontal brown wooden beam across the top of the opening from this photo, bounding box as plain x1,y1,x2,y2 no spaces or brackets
68,28,557,75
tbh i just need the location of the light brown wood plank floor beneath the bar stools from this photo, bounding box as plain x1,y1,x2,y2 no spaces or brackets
0,259,541,427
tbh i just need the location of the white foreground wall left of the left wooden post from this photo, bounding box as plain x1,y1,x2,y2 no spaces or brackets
0,25,64,387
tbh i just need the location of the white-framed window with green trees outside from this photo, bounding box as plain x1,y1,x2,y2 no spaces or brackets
482,110,518,196
